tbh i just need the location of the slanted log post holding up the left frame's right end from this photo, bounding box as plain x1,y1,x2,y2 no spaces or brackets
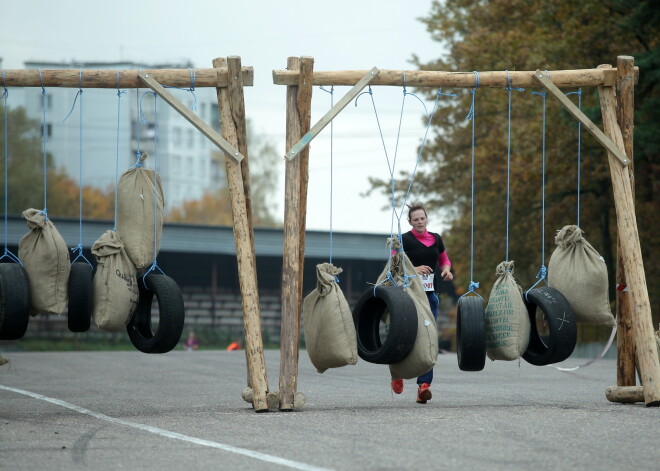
213,58,268,412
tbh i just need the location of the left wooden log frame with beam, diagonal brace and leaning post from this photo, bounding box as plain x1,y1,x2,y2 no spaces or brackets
4,56,272,412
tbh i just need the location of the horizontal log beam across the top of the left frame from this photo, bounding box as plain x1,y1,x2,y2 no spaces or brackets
0,67,254,88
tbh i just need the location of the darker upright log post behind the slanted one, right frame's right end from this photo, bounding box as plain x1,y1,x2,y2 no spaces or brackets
615,56,641,388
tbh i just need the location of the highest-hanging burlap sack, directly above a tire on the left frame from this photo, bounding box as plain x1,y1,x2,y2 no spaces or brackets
117,154,165,270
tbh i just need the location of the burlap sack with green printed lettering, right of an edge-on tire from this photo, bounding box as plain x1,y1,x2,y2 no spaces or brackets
485,261,531,361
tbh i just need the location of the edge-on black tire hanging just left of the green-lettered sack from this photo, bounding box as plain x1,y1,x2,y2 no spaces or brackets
456,296,486,371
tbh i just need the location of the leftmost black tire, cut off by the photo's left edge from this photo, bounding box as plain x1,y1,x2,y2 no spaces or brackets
0,263,30,340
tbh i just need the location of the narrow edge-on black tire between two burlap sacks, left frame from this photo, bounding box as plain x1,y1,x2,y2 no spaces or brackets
67,261,93,332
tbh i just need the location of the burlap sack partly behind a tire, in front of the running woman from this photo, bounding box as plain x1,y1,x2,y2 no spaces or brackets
378,237,438,379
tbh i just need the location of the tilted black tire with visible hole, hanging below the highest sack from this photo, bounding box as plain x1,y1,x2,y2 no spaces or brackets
126,273,185,353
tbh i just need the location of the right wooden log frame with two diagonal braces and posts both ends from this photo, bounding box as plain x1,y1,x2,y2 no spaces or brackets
273,56,660,410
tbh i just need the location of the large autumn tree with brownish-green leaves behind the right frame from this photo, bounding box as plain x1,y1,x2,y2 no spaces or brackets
372,0,660,324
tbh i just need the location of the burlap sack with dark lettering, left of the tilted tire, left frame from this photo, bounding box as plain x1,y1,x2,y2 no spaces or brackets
92,231,139,332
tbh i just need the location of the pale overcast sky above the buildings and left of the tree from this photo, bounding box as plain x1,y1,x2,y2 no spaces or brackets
0,0,443,233
